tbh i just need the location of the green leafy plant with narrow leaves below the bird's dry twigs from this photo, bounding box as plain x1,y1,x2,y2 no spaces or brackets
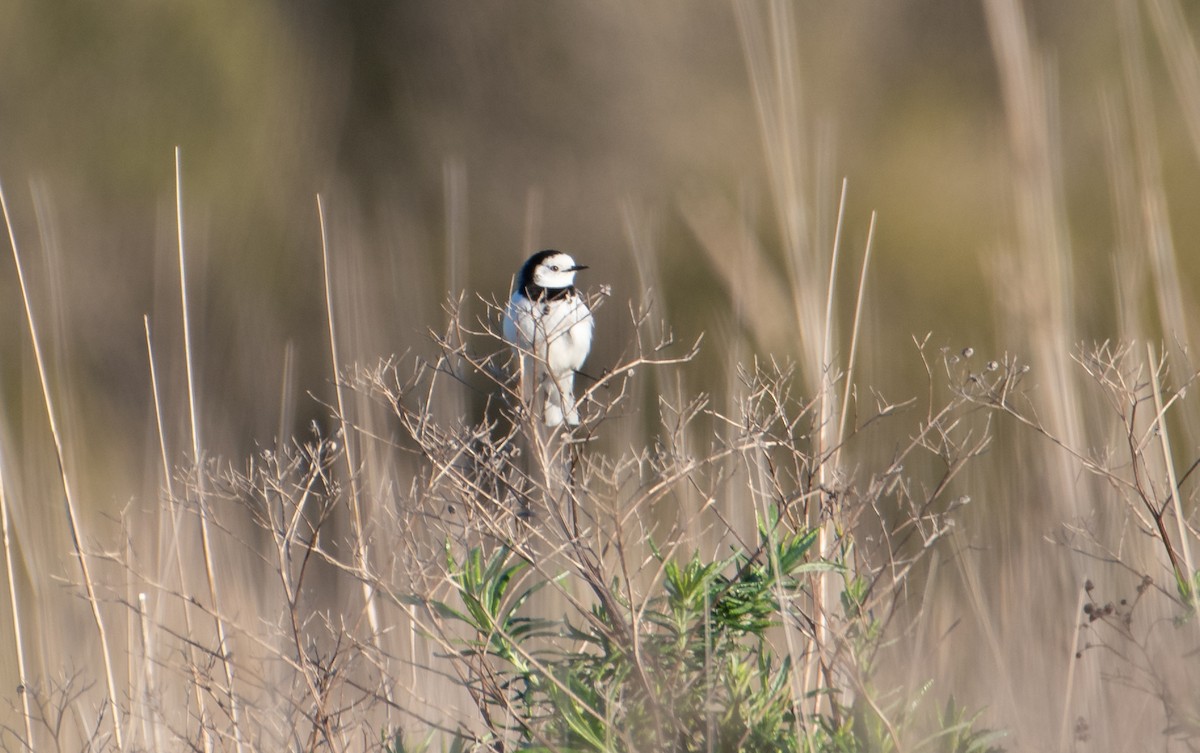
412,516,1000,753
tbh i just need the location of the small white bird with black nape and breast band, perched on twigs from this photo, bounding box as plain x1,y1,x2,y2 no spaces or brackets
504,248,595,427
